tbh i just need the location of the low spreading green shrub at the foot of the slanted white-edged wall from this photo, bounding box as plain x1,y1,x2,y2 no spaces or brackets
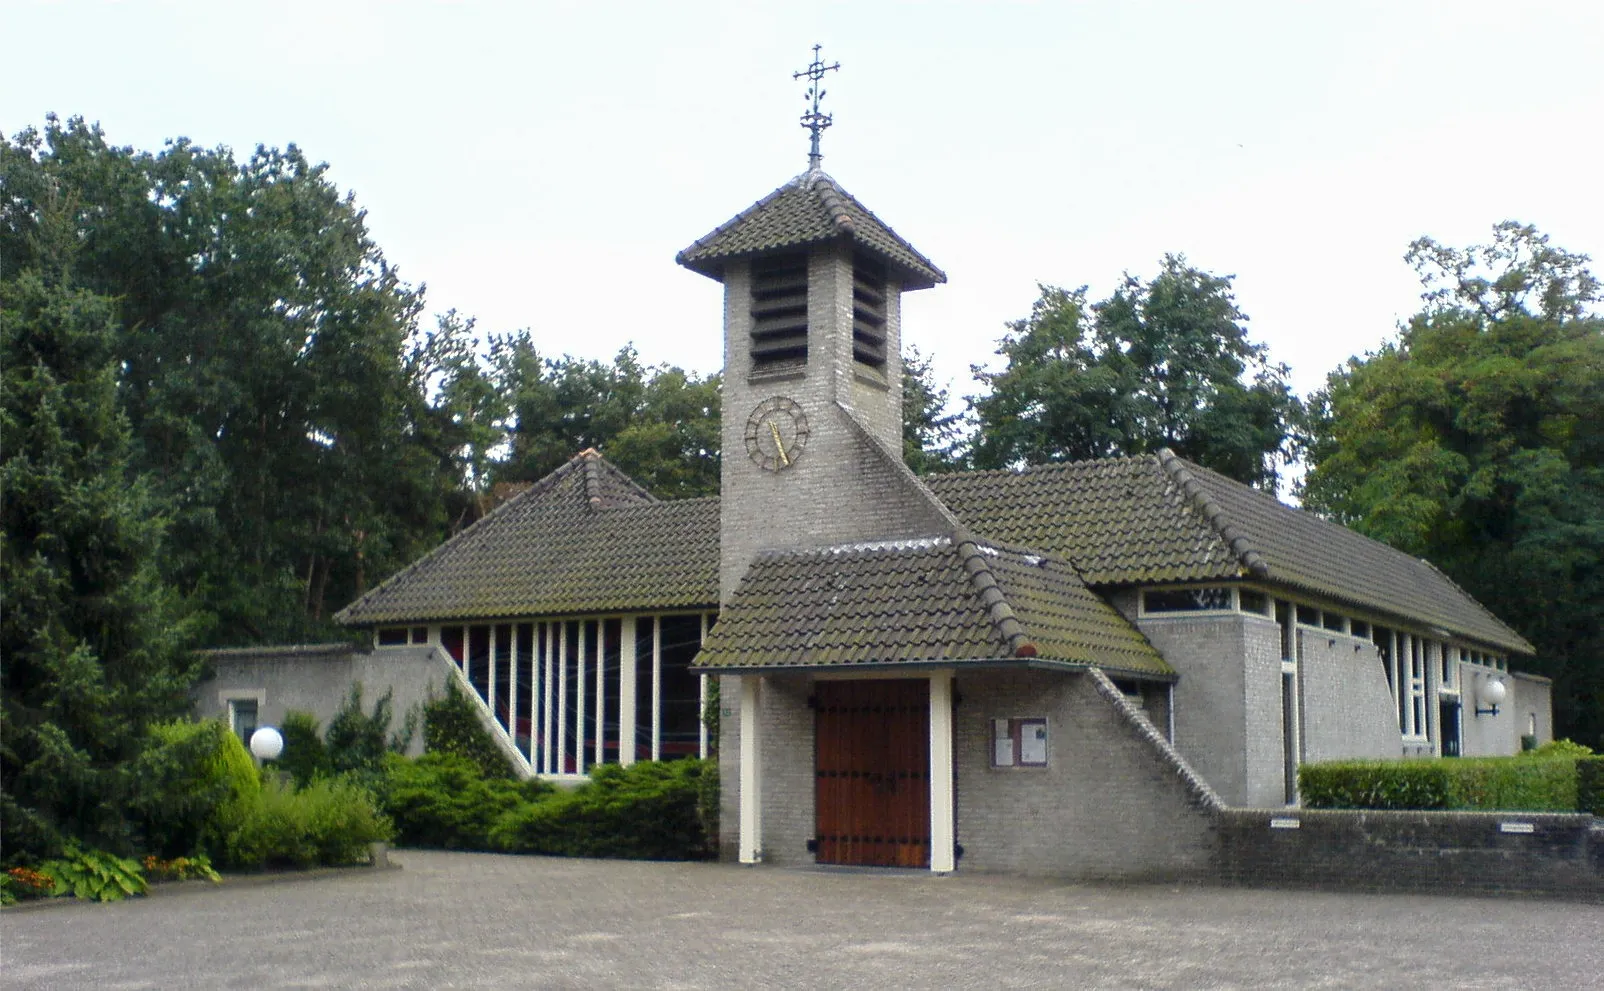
380,754,555,850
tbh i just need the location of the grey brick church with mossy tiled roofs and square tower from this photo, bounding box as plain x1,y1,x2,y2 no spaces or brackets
190,57,1551,877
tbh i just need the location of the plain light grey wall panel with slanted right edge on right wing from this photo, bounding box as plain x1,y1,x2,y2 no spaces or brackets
1298,629,1402,762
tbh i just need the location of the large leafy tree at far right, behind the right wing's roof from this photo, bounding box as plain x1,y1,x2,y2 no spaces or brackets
1302,223,1604,746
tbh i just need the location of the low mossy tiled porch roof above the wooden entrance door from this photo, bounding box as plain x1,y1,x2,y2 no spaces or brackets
698,532,1174,677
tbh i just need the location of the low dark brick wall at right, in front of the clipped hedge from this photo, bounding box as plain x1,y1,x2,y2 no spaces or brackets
1214,808,1604,901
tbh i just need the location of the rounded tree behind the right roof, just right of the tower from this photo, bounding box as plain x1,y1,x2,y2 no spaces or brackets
970,255,1301,489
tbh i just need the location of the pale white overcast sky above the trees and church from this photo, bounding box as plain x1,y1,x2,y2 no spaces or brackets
0,0,1604,394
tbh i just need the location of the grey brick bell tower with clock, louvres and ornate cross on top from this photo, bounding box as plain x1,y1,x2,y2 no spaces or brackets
677,47,946,600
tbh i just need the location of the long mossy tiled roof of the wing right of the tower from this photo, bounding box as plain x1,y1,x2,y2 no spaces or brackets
924,451,1532,653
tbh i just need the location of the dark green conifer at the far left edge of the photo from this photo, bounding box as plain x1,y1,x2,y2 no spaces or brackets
0,235,194,856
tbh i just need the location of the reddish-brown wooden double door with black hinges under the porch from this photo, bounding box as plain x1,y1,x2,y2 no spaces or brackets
813,678,930,868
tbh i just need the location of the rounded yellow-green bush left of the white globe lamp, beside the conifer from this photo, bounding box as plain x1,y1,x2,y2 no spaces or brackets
128,720,260,858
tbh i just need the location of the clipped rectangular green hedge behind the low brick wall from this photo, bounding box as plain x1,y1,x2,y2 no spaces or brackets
1298,757,1580,811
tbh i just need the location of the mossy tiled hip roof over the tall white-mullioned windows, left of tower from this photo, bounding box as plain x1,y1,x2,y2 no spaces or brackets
335,451,719,625
